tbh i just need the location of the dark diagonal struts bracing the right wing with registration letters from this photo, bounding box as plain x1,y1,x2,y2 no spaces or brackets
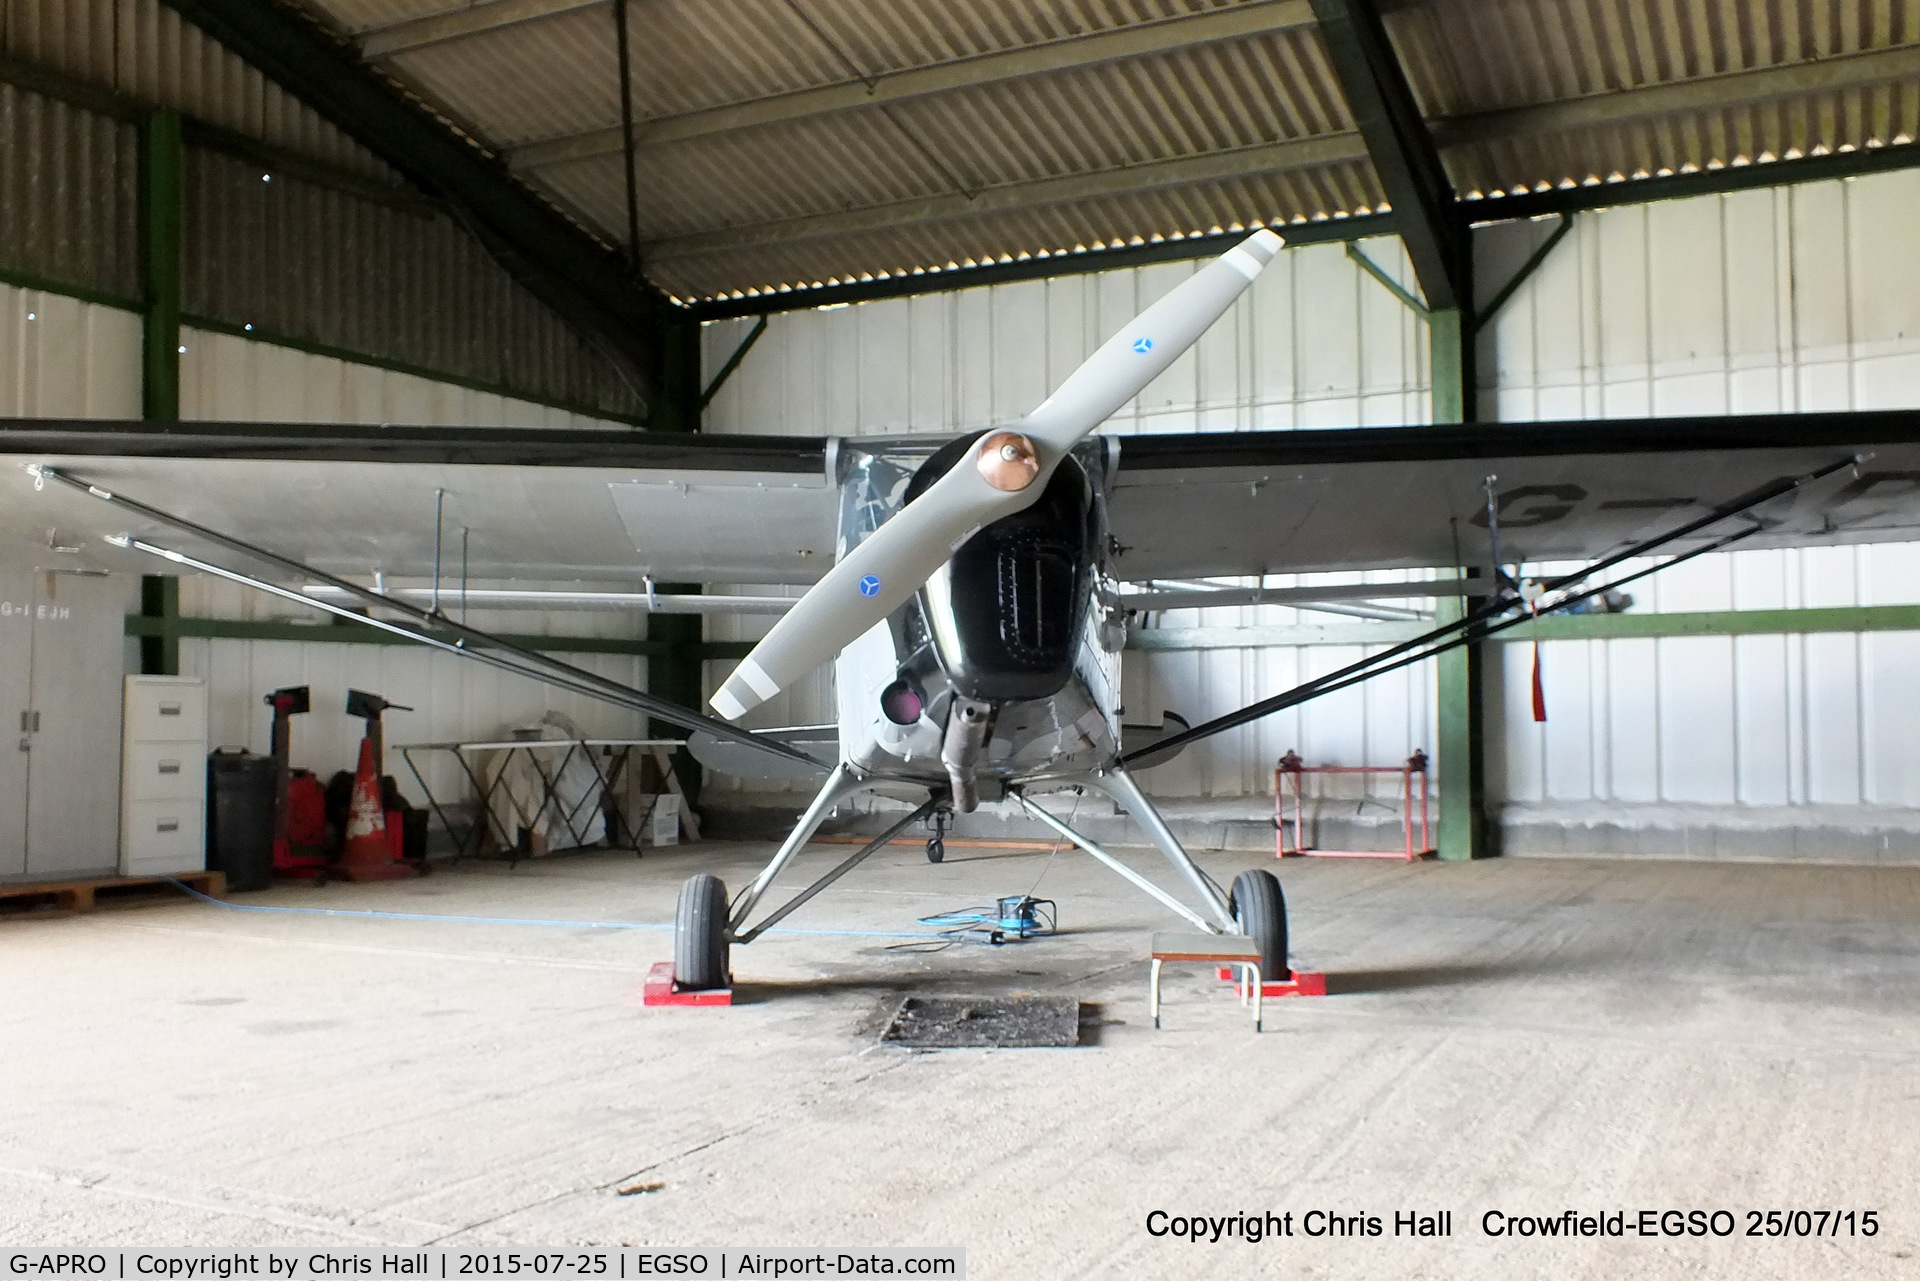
1119,455,1860,764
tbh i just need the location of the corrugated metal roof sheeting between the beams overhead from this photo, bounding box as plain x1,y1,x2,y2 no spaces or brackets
26,0,1920,298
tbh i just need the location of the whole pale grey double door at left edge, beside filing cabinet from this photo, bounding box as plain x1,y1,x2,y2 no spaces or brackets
0,568,127,880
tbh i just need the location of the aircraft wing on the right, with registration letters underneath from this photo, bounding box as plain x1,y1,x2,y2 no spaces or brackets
1108,411,1920,582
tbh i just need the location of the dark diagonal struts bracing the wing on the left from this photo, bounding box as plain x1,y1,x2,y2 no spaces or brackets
27,467,826,768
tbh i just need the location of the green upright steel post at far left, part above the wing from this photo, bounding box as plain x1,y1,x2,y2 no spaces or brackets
140,111,180,423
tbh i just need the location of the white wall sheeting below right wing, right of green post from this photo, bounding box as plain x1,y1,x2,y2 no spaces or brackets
1488,544,1920,807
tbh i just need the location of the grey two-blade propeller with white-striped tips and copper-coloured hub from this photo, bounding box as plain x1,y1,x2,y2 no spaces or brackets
712,230,1283,720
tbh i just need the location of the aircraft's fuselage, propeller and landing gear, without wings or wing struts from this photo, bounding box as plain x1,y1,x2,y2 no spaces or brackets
674,230,1286,989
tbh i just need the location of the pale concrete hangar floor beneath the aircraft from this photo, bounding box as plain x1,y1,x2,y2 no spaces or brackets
0,845,1920,1277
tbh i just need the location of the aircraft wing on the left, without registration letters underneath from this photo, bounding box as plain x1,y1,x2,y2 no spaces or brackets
0,419,839,584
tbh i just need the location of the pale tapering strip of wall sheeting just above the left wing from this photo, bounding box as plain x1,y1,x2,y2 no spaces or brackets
178,321,614,428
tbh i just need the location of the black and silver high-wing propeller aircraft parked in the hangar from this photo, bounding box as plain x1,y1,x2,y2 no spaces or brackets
0,230,1920,989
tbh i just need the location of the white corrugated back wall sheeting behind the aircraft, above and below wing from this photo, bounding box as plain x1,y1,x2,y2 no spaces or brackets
707,173,1920,812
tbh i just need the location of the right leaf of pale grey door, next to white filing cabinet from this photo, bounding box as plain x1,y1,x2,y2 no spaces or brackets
15,572,131,880
